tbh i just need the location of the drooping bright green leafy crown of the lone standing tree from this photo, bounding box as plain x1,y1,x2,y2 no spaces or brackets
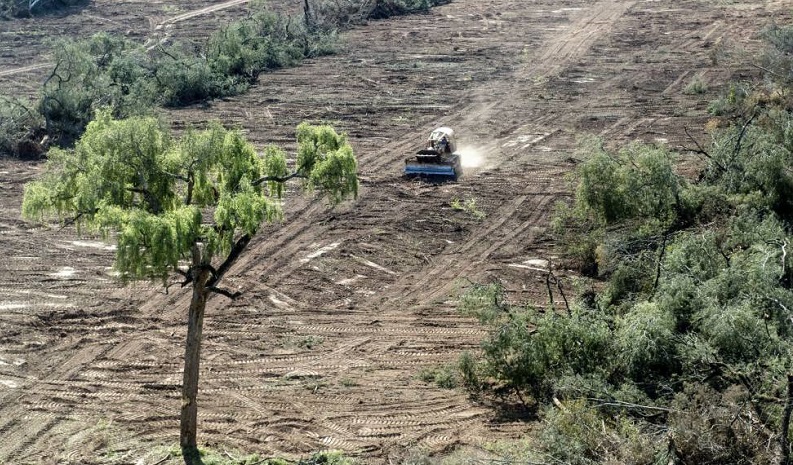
22,111,357,279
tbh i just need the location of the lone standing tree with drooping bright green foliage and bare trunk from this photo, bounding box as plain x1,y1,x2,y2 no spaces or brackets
22,112,358,465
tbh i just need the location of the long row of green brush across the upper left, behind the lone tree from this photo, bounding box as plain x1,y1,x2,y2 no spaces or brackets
0,0,447,157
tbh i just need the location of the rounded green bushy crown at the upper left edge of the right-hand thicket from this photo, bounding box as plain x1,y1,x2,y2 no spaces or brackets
551,139,684,276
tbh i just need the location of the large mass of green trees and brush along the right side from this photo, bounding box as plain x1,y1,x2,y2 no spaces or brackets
458,22,793,465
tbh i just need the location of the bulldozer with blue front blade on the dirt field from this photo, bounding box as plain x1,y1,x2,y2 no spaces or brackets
404,127,463,181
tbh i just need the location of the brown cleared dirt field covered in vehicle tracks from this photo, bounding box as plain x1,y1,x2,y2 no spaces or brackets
0,0,793,464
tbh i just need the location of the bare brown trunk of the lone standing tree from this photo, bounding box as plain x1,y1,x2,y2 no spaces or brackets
179,246,209,465
